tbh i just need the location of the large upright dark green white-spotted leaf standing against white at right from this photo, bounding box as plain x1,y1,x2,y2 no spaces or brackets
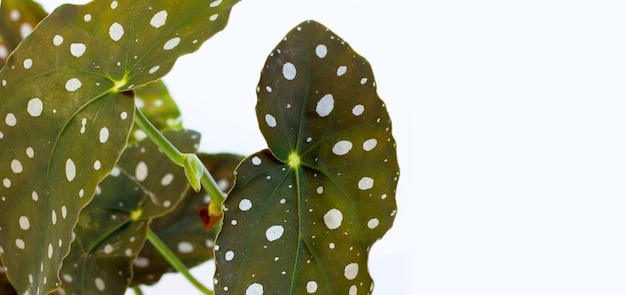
215,21,399,294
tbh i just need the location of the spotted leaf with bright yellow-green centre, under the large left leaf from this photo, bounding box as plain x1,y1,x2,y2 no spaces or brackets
61,130,200,294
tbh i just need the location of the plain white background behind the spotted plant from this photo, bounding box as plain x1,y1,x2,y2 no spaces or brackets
37,0,626,295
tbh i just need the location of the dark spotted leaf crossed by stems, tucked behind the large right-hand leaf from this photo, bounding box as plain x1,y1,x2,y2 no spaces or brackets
131,154,243,286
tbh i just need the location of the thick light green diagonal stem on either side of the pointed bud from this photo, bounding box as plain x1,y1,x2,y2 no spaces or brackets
135,108,226,207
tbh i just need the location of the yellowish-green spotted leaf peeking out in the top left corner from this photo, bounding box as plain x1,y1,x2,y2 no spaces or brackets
0,0,48,68
